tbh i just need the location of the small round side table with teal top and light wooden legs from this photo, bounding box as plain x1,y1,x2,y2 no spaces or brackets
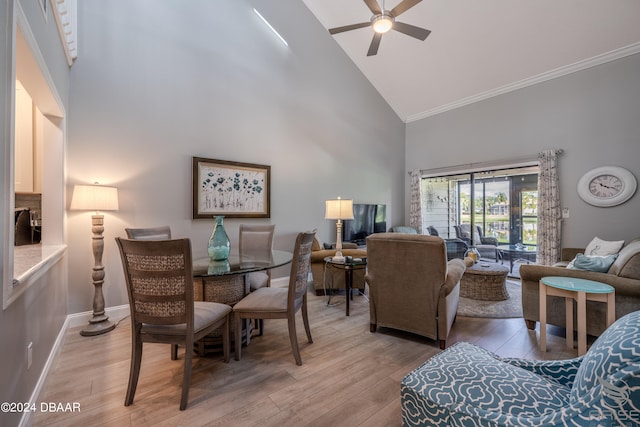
540,276,616,356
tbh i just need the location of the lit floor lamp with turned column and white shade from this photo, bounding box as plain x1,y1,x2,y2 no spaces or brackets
70,185,118,336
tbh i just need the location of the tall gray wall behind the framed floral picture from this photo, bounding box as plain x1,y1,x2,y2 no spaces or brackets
67,0,404,313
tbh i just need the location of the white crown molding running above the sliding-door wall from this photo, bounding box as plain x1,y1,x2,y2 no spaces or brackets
404,42,640,123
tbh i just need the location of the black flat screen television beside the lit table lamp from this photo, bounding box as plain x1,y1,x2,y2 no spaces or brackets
342,203,387,246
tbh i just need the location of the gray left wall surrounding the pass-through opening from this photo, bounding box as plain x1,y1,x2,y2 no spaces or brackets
0,0,69,426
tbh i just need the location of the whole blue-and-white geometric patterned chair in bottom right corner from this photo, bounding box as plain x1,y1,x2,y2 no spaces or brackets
401,311,640,427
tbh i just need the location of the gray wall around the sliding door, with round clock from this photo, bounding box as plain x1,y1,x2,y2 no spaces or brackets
405,54,640,247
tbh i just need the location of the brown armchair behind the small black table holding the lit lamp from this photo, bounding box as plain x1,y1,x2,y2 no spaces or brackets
311,235,367,295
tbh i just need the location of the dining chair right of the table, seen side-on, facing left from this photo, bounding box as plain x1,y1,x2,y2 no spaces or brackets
233,230,315,365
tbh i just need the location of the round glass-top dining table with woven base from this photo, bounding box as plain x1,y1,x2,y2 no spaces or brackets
193,250,293,356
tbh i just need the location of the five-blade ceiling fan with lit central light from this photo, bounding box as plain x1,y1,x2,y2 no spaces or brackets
329,0,431,56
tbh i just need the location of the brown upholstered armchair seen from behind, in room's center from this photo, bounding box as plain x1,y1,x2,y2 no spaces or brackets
365,233,466,348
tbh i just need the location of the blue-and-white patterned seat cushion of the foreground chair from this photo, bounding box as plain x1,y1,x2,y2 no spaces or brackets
401,342,570,426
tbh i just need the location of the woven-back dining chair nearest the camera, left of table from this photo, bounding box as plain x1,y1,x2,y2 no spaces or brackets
116,237,231,410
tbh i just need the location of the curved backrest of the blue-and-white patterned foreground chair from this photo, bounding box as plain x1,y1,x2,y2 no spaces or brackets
571,311,640,402
